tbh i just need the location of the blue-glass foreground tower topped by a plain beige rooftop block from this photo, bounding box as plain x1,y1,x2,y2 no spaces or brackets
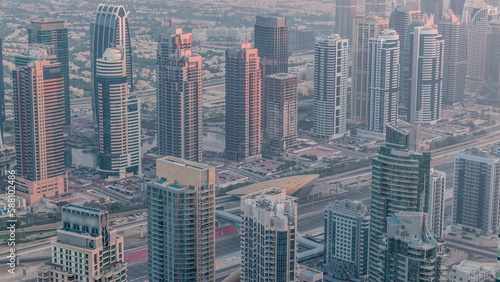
147,157,215,281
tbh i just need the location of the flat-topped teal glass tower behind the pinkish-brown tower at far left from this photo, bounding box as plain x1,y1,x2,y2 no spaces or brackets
28,20,71,125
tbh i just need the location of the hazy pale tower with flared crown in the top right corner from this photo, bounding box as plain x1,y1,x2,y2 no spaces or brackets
462,1,498,96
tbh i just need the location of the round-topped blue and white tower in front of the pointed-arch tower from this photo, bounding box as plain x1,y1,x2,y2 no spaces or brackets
95,48,142,179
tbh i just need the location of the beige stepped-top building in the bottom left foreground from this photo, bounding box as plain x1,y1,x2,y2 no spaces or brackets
38,205,127,282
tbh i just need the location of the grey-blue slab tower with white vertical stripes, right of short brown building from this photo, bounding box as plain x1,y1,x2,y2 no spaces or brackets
312,34,349,139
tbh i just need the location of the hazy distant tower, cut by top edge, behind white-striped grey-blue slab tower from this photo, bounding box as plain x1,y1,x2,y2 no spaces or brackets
335,0,358,40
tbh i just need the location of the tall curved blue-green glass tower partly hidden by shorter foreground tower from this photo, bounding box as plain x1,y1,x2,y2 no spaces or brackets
368,121,431,281
